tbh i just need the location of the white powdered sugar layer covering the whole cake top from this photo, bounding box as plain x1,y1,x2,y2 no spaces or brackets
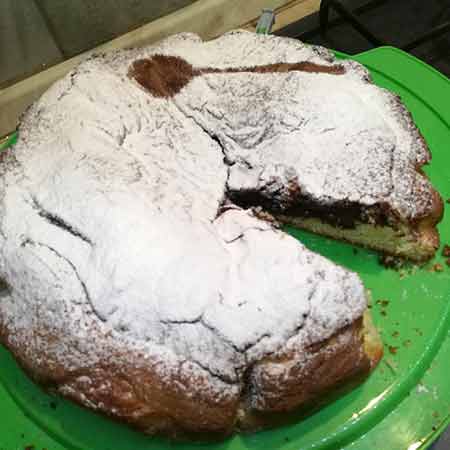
0,32,394,395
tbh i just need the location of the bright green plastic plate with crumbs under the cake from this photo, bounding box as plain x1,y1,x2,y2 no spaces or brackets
0,47,450,450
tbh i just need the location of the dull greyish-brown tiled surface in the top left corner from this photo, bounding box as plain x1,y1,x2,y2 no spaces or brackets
0,0,194,87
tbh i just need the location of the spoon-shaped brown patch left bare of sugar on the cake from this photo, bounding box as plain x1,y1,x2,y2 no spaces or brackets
128,55,345,98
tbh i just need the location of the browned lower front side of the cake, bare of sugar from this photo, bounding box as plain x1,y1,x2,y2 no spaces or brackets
0,310,383,441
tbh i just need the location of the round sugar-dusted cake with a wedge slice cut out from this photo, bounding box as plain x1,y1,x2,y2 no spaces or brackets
0,31,442,438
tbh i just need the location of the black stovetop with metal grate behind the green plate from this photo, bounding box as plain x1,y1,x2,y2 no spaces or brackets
278,0,450,75
